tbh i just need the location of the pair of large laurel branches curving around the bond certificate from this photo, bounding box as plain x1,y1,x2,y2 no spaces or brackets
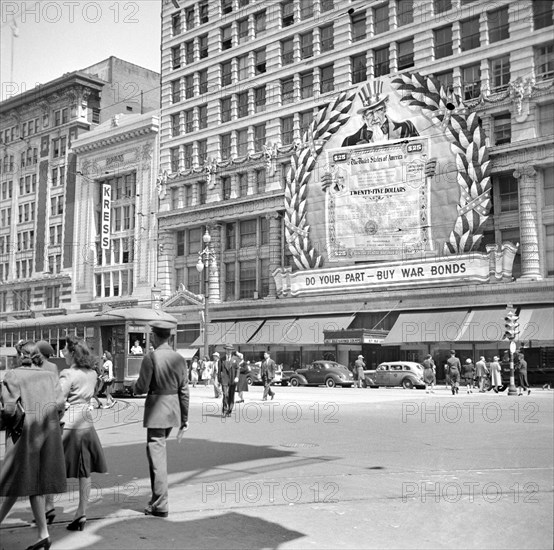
285,73,491,270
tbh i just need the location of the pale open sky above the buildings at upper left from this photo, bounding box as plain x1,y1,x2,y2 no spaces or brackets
0,0,162,100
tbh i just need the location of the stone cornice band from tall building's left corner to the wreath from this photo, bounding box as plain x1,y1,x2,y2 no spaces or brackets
158,191,283,231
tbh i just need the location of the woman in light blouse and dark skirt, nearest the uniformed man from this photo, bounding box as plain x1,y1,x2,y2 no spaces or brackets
60,335,107,531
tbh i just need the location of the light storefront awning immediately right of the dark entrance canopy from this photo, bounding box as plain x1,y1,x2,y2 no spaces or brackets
382,310,468,346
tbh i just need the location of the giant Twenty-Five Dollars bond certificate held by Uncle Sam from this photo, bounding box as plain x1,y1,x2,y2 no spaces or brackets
325,137,432,261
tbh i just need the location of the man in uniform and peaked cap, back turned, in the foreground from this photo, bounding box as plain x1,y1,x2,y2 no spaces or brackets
134,321,189,518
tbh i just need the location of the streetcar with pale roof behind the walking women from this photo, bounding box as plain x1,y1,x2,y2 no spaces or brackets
0,308,177,394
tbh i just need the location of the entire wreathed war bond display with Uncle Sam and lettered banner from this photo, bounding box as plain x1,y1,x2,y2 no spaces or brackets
273,74,511,296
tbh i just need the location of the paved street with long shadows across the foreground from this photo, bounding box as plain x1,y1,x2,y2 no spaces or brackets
1,386,554,550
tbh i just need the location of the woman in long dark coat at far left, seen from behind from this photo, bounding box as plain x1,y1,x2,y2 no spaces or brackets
0,342,66,549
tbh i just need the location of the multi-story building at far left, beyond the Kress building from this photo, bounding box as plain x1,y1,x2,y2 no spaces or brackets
0,57,159,319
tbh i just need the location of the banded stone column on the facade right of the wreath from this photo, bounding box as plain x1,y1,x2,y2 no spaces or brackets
514,166,542,280
